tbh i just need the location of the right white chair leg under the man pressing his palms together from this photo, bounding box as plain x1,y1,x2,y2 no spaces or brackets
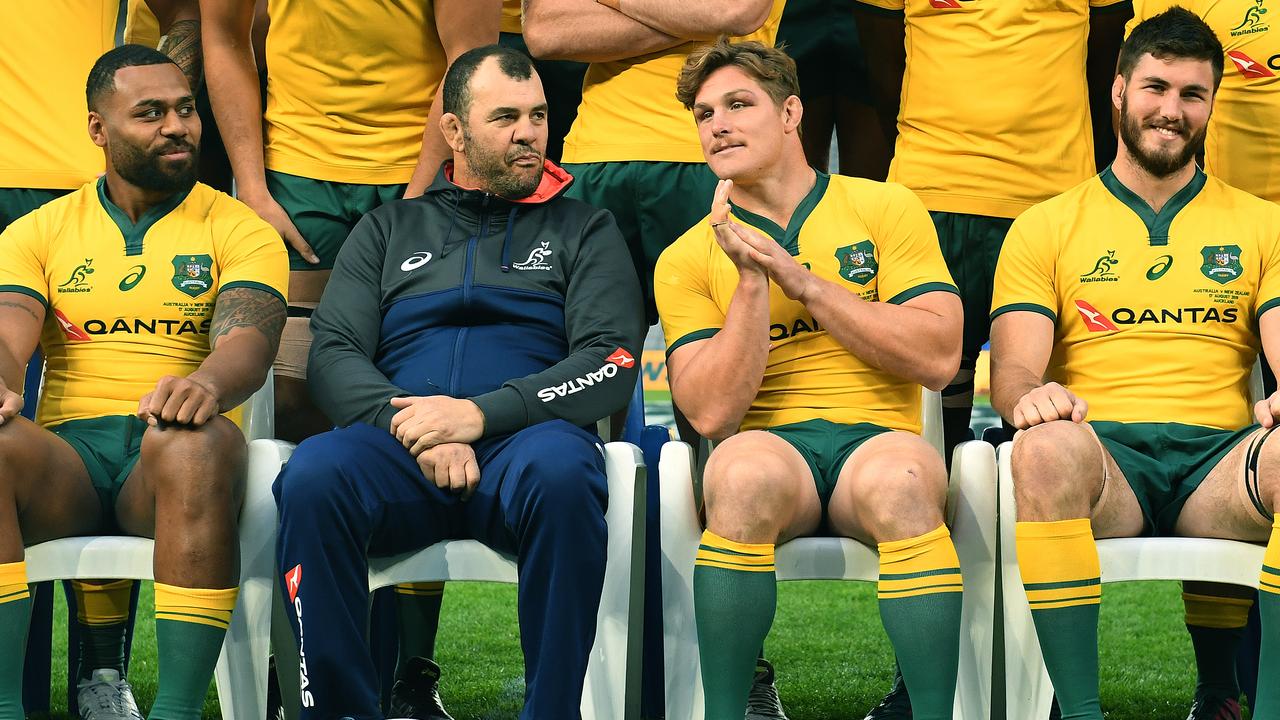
947,441,1002,717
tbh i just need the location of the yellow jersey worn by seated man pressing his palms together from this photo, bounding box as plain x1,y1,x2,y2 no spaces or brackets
654,173,956,433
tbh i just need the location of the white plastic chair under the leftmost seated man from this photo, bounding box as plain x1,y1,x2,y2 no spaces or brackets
26,375,287,719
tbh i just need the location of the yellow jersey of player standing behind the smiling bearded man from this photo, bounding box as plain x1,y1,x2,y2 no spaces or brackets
1125,0,1280,202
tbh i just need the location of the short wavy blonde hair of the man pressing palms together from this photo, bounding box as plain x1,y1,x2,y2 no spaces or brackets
676,36,800,110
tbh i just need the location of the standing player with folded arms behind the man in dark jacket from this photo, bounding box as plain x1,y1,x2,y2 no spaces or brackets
525,0,785,324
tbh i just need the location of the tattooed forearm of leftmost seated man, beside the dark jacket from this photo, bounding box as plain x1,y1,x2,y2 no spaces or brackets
189,287,284,413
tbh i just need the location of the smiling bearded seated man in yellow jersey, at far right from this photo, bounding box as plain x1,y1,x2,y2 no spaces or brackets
992,8,1280,720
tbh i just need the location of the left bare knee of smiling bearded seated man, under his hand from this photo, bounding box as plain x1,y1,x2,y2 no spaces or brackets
1011,420,1105,507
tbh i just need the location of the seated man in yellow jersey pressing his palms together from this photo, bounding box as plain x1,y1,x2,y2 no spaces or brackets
654,40,961,720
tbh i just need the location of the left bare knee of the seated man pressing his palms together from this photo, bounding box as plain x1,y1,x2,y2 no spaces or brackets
703,432,800,539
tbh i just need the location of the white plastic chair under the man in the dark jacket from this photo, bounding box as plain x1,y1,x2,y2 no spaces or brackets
273,442,645,720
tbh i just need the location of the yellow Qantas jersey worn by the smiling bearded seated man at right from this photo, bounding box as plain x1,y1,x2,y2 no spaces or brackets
992,168,1280,429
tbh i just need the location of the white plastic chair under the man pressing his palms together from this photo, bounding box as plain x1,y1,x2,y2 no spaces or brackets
658,391,996,720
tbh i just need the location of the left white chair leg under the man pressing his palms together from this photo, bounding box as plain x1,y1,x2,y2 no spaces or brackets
659,442,703,720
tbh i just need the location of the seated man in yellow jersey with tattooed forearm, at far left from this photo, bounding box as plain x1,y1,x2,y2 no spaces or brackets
0,45,287,720
